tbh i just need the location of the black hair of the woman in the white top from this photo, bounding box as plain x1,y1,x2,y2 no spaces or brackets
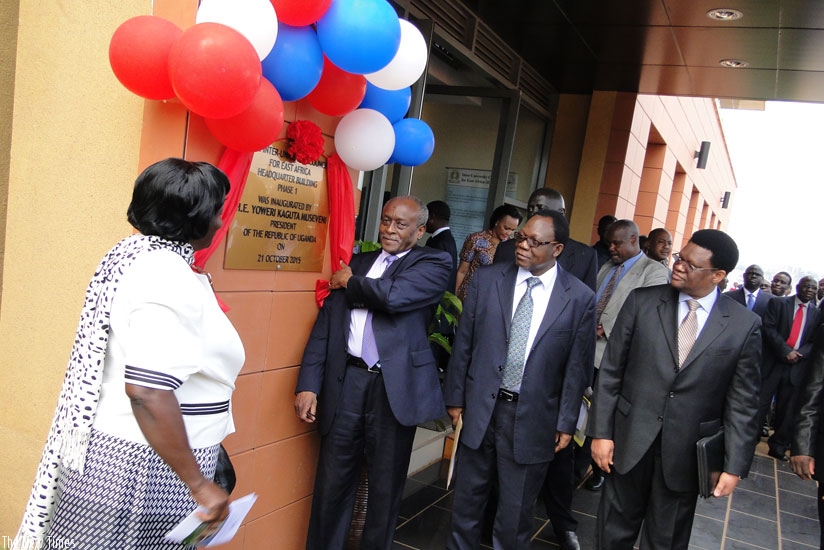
126,158,229,243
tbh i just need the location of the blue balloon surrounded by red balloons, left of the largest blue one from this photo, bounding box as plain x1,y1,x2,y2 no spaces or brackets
261,22,323,101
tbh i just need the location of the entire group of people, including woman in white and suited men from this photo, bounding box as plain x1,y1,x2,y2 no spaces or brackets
14,159,824,550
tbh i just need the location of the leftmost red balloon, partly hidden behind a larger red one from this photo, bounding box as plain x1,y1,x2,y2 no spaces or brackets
109,15,183,99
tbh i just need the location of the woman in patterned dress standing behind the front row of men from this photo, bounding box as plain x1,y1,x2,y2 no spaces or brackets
455,204,523,301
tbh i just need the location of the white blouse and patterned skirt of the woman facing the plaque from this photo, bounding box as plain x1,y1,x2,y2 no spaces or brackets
45,249,244,550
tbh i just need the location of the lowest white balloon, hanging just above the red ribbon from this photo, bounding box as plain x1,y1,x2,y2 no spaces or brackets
335,109,395,172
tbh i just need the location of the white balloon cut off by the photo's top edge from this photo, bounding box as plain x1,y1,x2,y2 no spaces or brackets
195,0,278,59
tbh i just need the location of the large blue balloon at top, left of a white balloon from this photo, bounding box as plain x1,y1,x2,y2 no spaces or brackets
317,0,401,74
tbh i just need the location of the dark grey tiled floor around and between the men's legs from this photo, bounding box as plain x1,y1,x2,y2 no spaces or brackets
393,443,819,550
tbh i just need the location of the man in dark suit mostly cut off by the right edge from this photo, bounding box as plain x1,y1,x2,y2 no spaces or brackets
790,326,824,548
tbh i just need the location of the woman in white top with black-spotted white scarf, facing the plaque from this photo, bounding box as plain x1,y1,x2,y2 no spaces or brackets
13,159,244,550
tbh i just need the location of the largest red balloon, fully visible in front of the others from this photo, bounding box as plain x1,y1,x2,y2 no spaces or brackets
169,23,261,118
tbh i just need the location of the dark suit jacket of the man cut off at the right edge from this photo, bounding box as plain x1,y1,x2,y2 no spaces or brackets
792,325,824,482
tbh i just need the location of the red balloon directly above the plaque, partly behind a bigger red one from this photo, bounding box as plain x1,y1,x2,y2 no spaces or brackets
205,78,283,153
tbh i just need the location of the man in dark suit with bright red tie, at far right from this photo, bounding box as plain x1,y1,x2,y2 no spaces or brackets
759,277,821,460
